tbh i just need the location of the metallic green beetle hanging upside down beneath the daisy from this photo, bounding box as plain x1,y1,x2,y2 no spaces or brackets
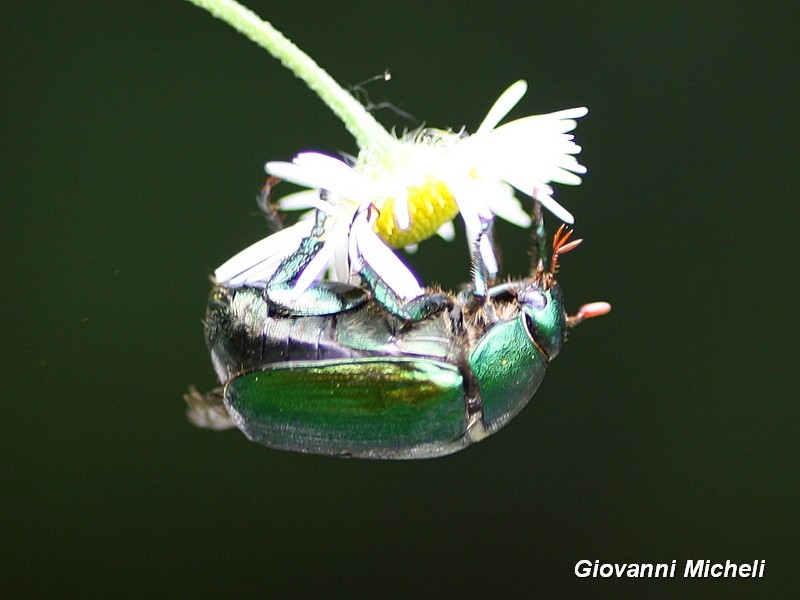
186,203,610,459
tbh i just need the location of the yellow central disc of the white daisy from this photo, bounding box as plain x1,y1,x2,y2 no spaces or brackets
373,176,458,248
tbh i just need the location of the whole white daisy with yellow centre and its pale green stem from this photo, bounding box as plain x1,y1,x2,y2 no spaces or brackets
190,0,587,298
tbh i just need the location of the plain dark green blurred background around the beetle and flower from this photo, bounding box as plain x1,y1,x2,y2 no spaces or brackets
0,0,800,598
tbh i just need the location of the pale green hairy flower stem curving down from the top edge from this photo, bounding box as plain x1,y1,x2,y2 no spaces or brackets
182,0,394,155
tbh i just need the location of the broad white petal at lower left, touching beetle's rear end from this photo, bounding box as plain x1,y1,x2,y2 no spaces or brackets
214,221,313,287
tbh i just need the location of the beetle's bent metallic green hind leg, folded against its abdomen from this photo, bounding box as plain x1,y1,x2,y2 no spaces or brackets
264,210,367,316
